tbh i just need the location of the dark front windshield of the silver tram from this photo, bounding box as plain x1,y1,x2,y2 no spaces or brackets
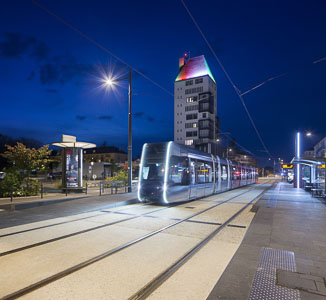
141,144,166,182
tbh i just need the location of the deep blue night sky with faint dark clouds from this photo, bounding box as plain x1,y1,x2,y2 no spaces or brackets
0,0,326,165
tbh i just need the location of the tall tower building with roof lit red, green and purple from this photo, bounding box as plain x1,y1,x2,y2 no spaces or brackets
174,54,219,154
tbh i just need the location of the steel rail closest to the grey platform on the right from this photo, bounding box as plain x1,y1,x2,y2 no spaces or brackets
128,185,273,300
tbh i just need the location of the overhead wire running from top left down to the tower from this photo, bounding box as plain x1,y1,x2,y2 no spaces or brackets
32,0,173,97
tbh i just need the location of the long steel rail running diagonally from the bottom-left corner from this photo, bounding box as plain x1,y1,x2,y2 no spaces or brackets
2,182,269,300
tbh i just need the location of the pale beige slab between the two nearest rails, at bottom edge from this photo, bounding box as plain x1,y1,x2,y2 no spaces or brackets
23,230,199,300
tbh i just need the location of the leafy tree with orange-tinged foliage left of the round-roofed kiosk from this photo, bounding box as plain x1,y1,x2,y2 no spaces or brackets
1,142,51,173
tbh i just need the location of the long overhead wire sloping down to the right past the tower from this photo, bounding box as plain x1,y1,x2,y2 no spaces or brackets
181,0,273,158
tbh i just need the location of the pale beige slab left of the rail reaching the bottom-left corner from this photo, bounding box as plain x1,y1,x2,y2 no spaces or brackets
0,225,154,299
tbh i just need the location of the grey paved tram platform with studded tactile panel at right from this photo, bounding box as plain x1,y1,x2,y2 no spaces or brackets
207,182,326,300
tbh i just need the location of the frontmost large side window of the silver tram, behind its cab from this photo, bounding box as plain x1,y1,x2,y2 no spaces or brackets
169,155,191,185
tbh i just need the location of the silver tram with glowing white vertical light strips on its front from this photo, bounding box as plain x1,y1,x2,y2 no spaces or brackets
138,142,258,204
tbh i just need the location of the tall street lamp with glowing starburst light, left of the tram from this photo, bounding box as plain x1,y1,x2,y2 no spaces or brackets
104,69,132,193
